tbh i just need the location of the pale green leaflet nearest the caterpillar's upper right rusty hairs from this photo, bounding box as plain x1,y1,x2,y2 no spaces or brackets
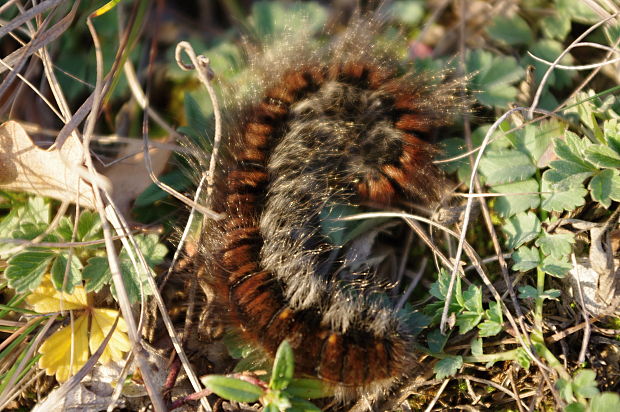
479,150,536,186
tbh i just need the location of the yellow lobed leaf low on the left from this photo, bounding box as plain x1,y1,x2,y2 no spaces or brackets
26,276,131,382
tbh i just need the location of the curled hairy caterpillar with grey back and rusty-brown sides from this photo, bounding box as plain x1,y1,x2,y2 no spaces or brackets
195,20,464,395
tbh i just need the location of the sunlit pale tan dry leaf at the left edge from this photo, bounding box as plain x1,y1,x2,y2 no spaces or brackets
0,121,110,209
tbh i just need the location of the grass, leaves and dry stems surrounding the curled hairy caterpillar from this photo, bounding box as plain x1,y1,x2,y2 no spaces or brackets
0,0,620,412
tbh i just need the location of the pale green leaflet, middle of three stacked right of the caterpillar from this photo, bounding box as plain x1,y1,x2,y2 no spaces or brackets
491,179,540,217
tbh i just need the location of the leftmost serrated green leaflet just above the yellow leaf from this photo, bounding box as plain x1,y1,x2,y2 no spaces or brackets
4,250,56,293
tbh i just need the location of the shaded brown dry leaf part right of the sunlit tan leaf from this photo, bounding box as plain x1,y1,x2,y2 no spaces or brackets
103,140,172,216
